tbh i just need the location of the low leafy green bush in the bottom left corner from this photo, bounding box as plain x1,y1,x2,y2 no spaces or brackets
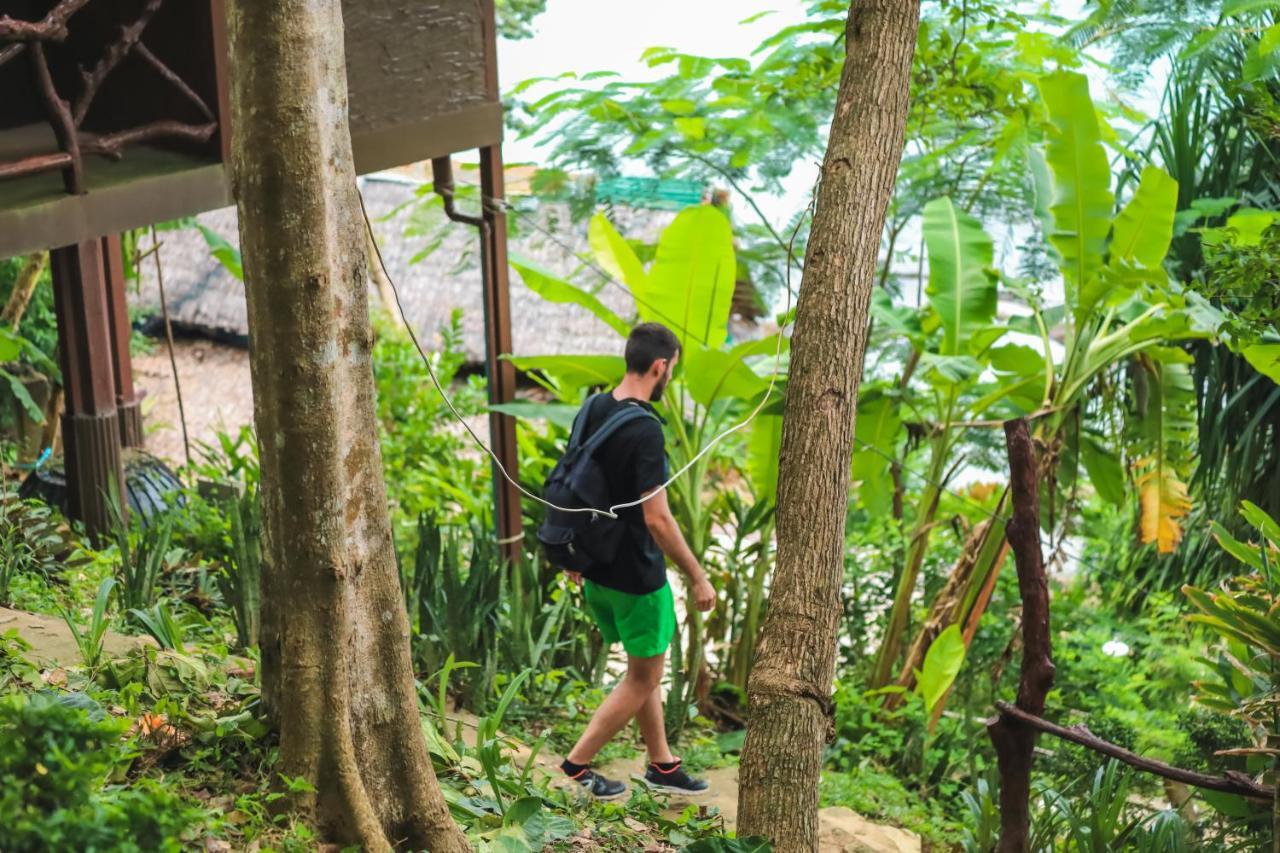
0,694,202,853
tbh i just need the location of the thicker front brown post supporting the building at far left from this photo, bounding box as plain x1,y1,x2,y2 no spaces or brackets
50,240,124,537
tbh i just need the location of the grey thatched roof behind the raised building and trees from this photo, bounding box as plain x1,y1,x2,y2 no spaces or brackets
136,177,753,362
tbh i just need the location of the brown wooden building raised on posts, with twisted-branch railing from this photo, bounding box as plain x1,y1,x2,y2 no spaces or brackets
0,0,520,548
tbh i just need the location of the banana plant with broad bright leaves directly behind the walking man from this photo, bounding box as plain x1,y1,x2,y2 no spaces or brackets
500,205,787,735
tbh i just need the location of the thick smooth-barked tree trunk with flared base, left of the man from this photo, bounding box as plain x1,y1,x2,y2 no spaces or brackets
228,0,470,852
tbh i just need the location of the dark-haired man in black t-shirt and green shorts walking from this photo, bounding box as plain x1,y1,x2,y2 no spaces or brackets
561,323,716,799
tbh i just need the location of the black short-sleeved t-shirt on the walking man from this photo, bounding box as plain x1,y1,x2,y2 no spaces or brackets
584,394,667,596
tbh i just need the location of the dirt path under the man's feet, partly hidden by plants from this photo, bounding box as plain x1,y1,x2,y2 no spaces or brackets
452,712,922,853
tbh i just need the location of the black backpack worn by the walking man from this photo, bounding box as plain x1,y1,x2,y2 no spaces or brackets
538,394,658,574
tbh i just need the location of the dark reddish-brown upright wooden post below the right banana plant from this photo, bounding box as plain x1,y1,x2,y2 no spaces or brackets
987,419,1053,853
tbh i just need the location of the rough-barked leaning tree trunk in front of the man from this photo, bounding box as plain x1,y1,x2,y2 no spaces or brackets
739,0,920,853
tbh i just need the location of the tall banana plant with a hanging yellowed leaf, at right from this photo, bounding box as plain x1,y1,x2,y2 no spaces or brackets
872,72,1222,686
